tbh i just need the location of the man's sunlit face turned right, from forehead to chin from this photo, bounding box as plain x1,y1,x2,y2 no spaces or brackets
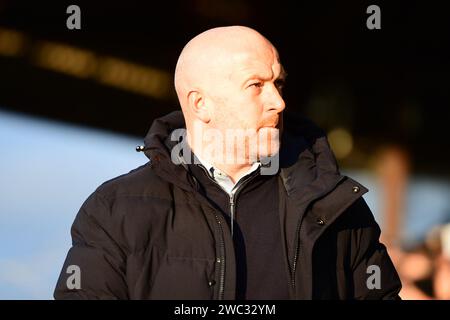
209,44,285,158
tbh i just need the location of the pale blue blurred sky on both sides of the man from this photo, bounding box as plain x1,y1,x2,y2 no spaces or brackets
0,110,450,299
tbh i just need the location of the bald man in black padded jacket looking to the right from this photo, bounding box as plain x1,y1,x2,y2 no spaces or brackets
54,26,401,300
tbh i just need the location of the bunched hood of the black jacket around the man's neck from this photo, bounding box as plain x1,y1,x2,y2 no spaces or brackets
144,111,343,195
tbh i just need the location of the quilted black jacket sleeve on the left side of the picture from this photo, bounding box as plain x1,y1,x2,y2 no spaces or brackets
54,191,128,299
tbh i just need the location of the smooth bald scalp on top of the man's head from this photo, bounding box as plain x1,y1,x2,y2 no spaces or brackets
175,26,277,112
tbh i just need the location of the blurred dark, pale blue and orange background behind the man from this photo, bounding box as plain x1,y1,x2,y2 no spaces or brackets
0,0,450,299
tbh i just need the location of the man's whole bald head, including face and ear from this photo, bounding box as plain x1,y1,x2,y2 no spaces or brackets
175,26,285,172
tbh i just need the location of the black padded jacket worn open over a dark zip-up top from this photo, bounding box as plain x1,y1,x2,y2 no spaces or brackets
54,112,401,299
